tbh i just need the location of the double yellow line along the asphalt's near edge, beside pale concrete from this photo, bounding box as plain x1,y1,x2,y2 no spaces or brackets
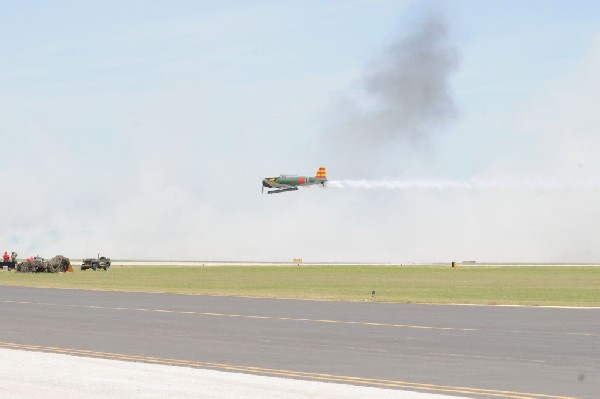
0,341,576,399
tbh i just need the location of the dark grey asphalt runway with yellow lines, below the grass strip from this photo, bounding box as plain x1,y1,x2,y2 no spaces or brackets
0,287,600,399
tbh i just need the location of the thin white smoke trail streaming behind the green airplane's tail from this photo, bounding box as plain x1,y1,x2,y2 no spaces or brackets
327,179,600,190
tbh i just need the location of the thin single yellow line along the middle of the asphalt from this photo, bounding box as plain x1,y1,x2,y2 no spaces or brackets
2,301,477,331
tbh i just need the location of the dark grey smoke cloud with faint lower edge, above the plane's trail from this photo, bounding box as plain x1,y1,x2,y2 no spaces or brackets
325,9,459,178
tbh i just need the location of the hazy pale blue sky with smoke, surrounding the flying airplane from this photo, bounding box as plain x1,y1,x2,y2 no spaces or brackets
0,0,600,262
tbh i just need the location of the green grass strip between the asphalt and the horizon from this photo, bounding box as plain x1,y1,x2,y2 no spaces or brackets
0,266,600,306
